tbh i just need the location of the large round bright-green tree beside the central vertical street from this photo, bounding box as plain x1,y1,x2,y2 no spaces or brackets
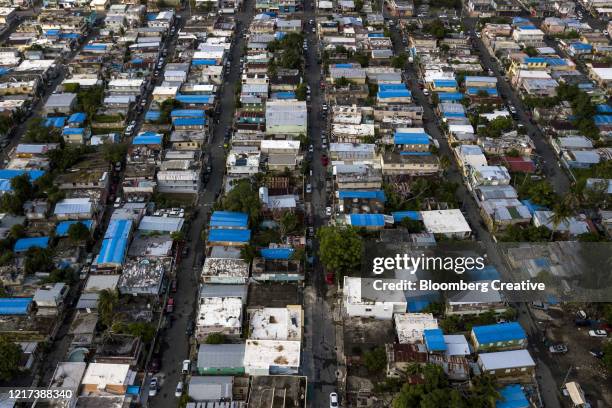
317,226,363,280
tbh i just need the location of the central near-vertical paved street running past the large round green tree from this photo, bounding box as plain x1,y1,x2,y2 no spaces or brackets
302,0,338,408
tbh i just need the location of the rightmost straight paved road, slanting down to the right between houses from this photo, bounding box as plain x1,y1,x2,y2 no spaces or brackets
463,18,570,194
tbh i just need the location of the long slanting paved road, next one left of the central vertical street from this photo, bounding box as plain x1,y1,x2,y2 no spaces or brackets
146,0,254,408
